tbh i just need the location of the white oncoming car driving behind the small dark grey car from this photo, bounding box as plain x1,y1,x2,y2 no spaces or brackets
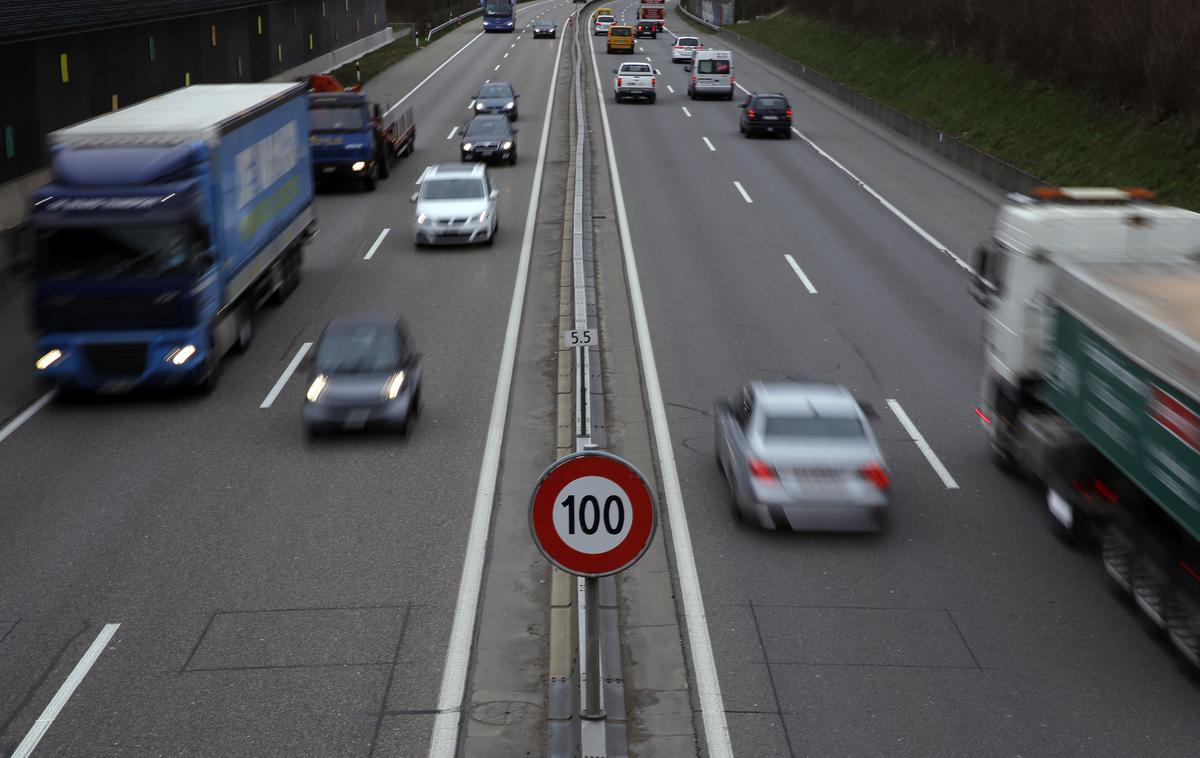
412,163,500,245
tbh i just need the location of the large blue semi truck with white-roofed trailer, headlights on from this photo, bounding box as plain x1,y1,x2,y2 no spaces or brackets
30,83,314,392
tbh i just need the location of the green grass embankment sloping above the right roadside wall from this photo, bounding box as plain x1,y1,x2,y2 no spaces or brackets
680,13,1200,210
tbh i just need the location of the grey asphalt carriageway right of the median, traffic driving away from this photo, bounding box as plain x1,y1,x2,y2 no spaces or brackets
593,4,1200,756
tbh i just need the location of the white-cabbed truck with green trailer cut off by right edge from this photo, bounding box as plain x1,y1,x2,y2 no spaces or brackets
971,187,1200,666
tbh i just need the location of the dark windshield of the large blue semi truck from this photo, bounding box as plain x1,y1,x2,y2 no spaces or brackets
36,223,204,279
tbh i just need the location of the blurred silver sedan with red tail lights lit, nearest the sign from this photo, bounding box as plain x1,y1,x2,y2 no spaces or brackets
715,381,890,531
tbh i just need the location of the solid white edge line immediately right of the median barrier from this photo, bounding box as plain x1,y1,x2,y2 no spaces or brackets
588,23,733,758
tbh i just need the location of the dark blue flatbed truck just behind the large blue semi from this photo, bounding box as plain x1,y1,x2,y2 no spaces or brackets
308,92,416,192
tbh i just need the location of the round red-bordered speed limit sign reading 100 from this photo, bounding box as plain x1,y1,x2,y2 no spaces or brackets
529,451,658,577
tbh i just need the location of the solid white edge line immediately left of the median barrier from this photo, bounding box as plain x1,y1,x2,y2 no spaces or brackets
430,7,566,758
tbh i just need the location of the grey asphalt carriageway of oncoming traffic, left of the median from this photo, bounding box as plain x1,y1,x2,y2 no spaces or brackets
0,0,571,756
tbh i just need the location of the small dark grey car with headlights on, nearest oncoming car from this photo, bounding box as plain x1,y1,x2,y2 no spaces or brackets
302,315,421,435
